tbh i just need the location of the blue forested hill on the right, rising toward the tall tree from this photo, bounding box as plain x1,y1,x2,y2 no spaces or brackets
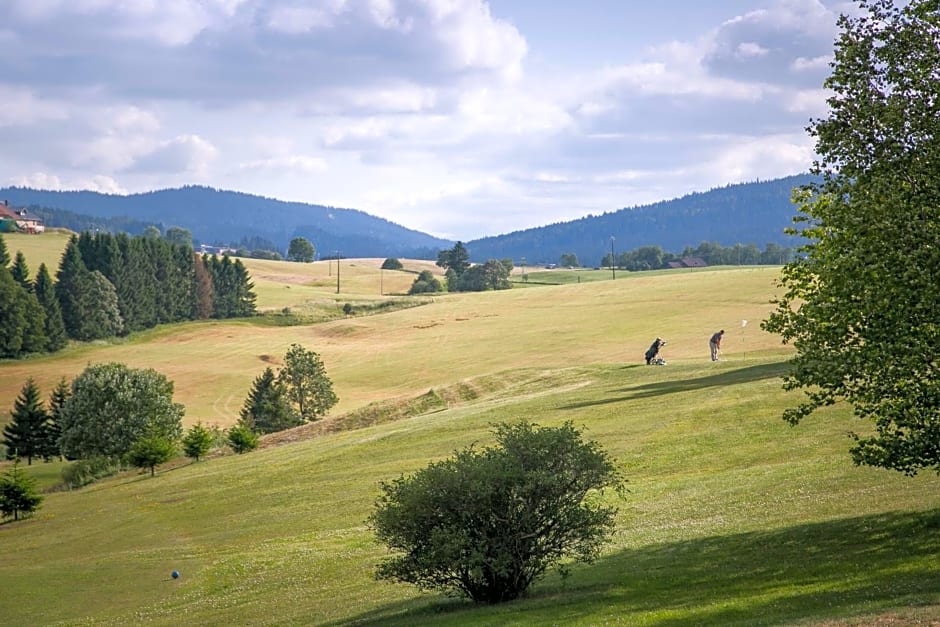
466,174,812,266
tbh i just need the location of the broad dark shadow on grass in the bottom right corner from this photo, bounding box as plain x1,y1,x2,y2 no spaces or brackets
334,509,940,625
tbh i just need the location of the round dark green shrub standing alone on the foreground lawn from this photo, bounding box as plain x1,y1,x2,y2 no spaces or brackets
370,422,623,603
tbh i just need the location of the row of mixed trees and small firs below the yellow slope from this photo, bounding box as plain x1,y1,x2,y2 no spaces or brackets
0,344,338,498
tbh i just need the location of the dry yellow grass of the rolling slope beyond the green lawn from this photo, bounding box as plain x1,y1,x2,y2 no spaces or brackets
0,259,780,426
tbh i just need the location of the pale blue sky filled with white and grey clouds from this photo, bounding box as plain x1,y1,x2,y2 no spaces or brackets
0,0,853,241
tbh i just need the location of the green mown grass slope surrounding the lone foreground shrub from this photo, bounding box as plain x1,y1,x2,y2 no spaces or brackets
0,357,940,625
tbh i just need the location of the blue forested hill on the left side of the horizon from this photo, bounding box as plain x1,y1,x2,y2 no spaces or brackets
0,186,453,258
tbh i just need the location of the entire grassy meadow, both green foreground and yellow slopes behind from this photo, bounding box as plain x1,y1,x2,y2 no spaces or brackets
0,233,940,625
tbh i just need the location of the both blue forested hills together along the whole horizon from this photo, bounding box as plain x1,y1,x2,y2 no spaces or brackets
0,174,811,265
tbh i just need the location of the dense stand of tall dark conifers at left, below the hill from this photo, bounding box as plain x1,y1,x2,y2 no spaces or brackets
0,231,256,358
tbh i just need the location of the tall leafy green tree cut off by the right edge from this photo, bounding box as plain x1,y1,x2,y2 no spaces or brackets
764,0,940,475
